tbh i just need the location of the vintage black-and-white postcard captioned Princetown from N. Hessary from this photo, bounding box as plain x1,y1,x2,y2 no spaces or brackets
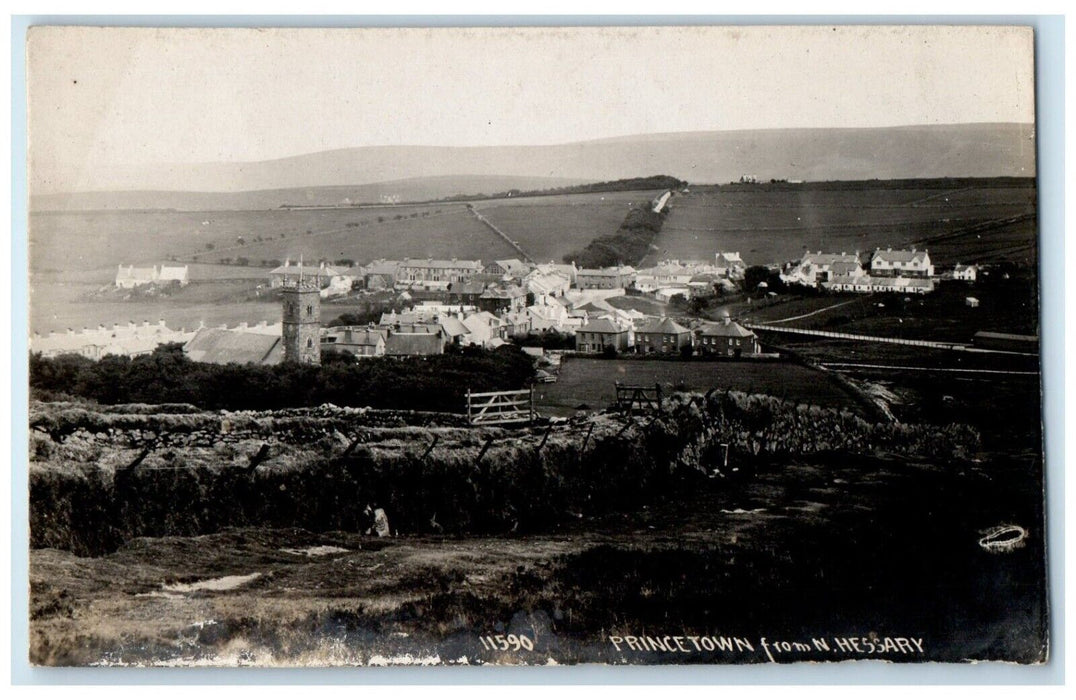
27,26,1049,667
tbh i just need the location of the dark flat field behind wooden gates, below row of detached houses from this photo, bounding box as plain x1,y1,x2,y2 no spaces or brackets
535,357,858,416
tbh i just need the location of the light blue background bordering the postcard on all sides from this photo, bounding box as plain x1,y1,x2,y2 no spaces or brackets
11,15,1065,685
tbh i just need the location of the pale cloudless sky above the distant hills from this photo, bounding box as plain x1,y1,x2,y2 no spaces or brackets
28,26,1034,191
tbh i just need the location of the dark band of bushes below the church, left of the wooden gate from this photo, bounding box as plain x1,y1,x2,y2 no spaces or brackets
30,344,534,413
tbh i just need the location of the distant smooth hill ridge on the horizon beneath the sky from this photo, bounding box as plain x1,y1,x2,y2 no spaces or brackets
32,124,1035,210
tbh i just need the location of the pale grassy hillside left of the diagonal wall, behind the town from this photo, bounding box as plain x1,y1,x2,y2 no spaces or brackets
30,203,511,271
